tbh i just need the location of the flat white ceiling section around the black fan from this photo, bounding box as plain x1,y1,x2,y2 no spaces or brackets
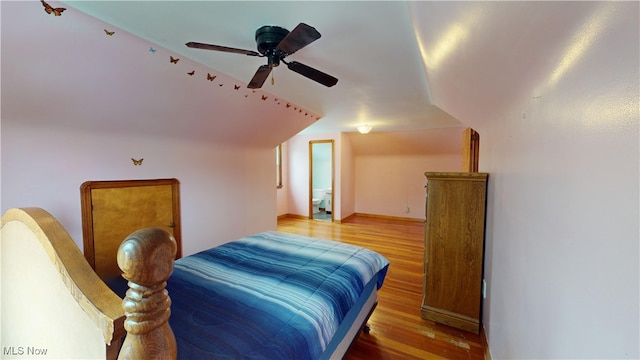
56,1,460,132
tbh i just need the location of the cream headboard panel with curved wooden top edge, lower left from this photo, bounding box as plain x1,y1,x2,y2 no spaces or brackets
0,208,125,359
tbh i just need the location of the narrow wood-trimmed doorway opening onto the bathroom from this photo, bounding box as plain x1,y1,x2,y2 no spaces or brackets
309,140,334,221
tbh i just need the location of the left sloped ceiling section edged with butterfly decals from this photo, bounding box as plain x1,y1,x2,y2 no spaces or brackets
1,1,320,147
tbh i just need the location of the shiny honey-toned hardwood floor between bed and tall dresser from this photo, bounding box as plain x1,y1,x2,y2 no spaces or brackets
278,216,484,360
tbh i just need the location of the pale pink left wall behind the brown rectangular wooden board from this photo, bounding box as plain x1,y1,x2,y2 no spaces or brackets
2,123,276,255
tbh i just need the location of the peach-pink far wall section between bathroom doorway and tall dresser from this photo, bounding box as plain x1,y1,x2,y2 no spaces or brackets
348,127,462,219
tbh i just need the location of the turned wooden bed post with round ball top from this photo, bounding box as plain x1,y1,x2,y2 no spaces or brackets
118,228,177,360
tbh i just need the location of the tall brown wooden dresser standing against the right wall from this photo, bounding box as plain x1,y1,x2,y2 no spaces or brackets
422,172,488,334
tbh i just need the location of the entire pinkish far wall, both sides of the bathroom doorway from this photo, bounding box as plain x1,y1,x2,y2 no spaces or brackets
278,128,463,220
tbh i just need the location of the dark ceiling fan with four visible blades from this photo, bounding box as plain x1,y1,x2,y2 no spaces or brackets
185,23,338,89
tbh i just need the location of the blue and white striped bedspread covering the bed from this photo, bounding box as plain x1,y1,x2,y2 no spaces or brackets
167,231,389,360
